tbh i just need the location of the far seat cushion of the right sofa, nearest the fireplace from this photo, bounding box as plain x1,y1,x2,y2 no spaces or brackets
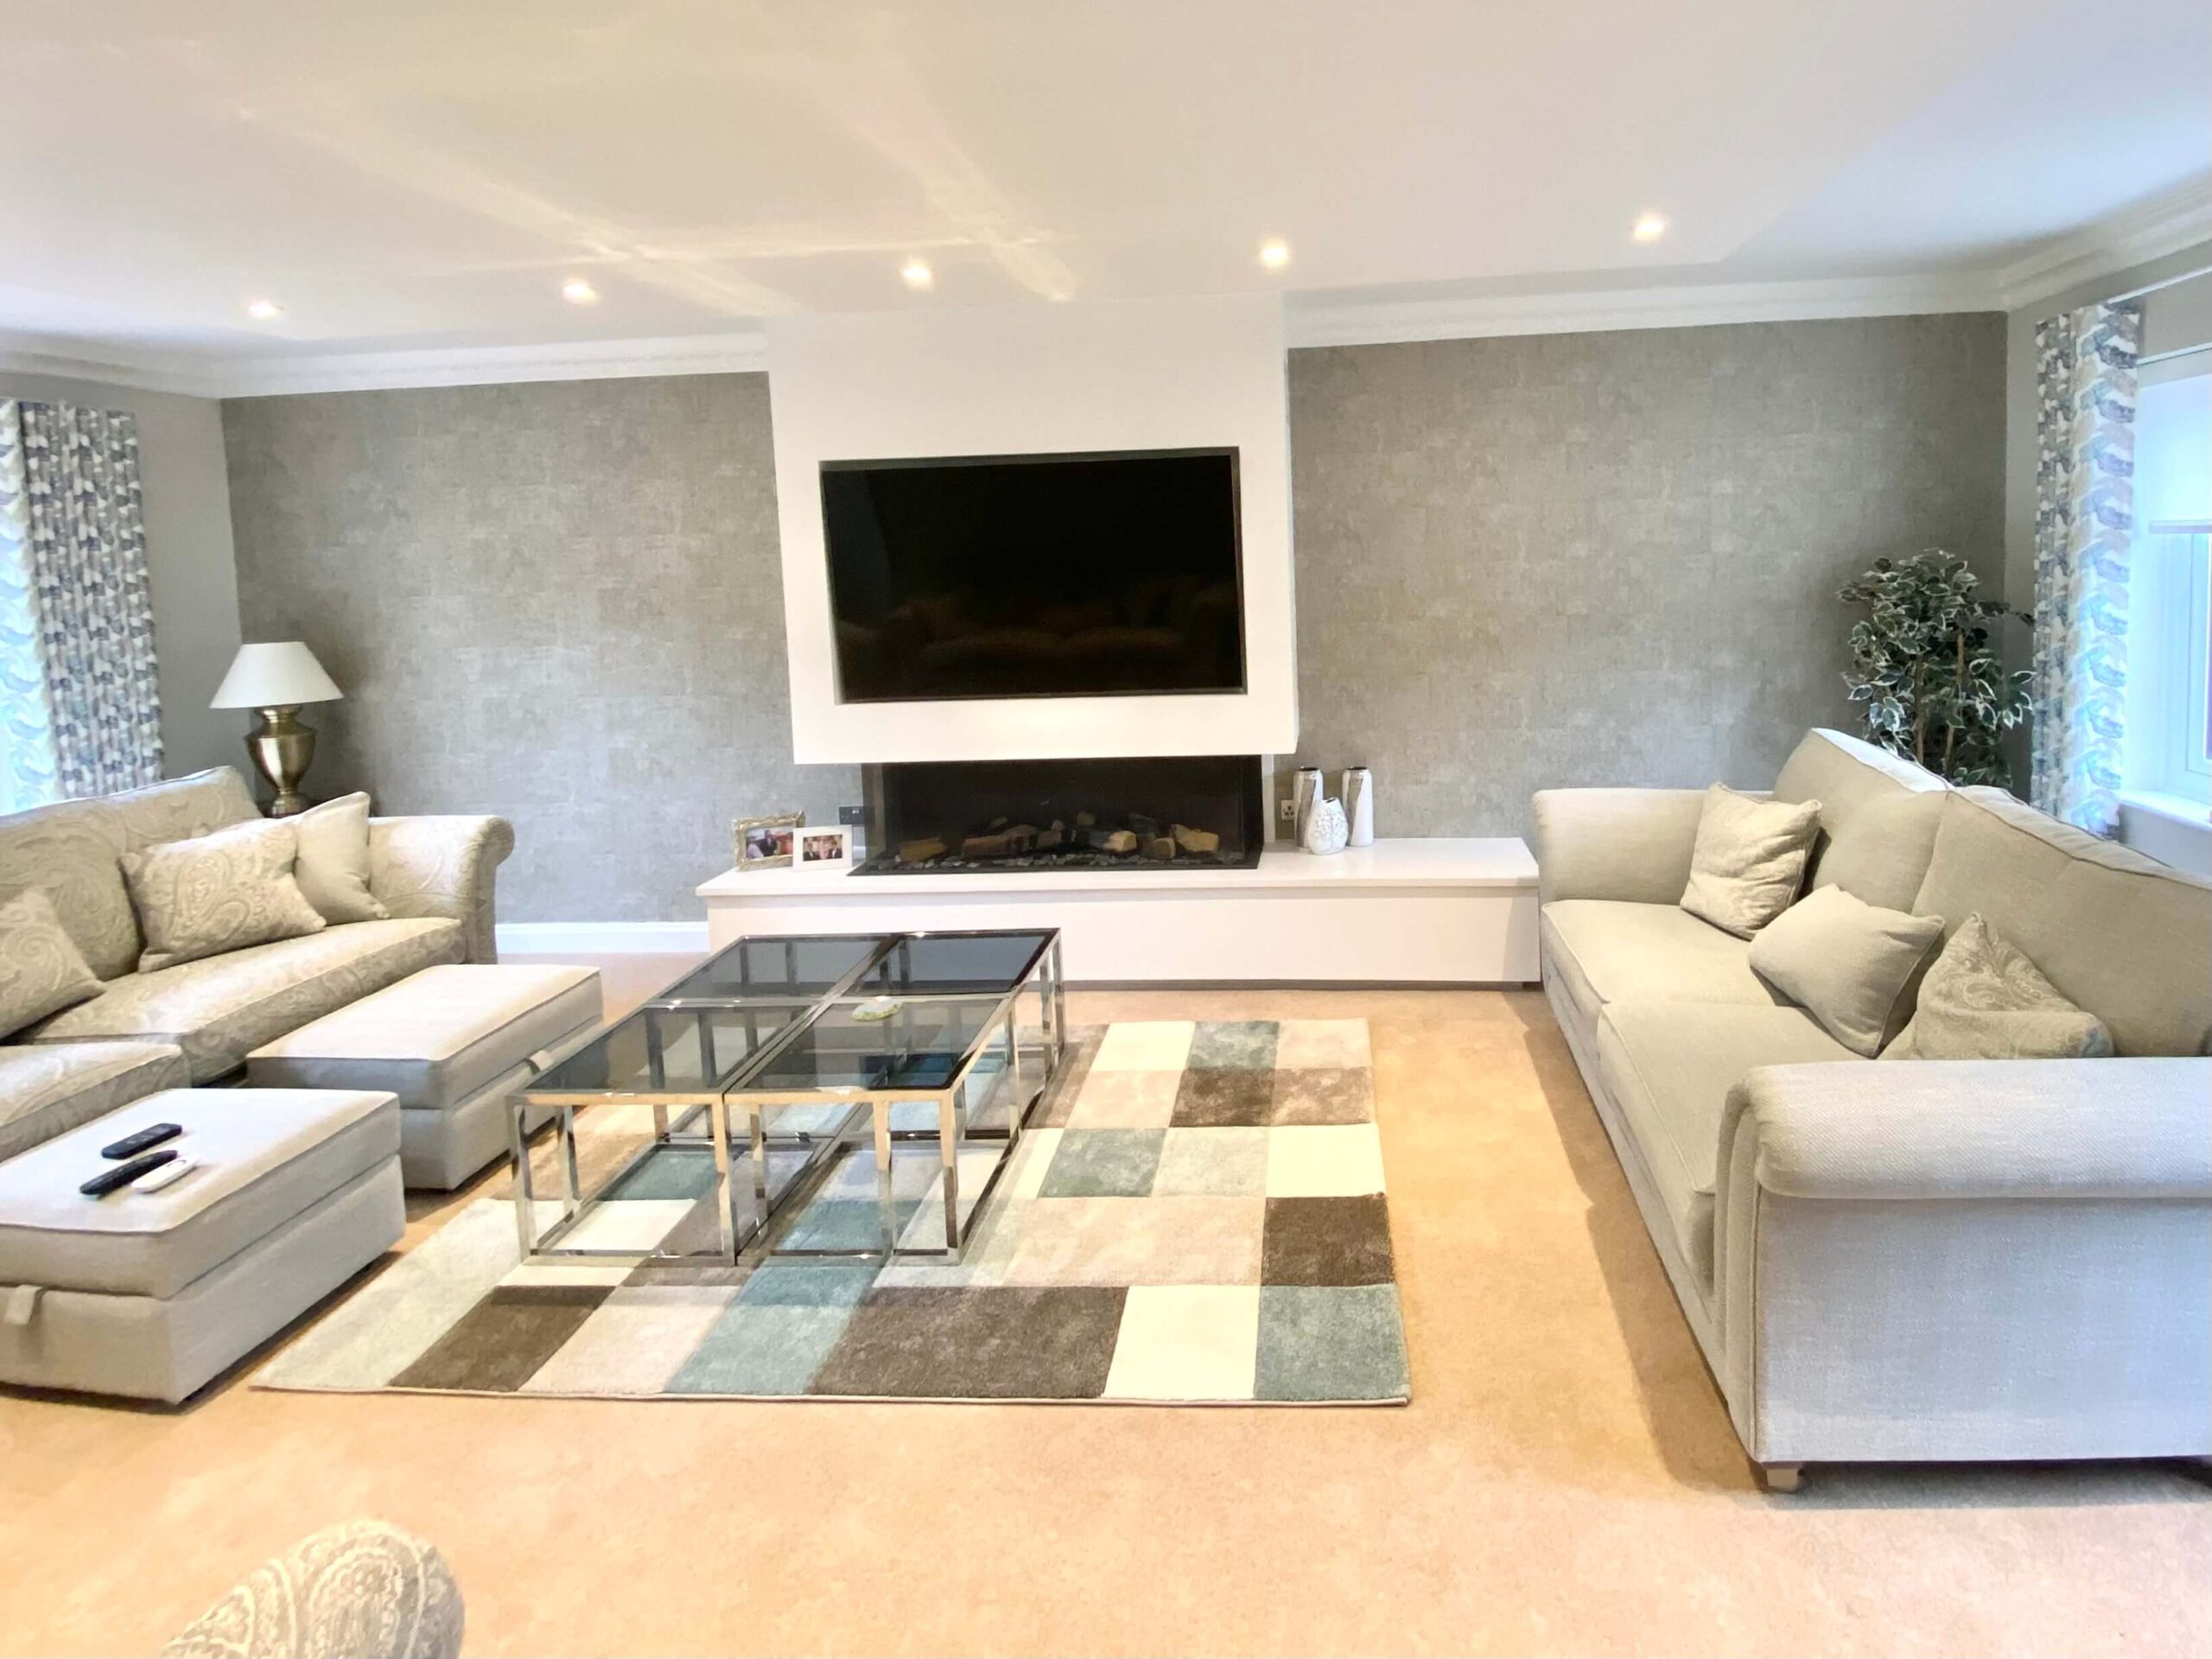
1544,898,1781,1022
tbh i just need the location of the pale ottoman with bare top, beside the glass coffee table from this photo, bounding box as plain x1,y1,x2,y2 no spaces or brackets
245,963,601,1190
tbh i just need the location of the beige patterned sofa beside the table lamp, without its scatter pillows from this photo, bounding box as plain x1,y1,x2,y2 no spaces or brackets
0,766,515,1157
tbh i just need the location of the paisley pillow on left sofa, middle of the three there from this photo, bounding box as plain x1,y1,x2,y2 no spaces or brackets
124,818,329,973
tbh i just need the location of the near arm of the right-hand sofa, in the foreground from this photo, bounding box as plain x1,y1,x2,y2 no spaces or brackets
1712,1059,2212,1465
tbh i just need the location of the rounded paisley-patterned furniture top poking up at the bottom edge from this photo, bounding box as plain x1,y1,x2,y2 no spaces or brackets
163,1522,462,1659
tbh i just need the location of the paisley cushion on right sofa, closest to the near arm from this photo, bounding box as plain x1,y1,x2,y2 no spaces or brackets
1883,916,2113,1059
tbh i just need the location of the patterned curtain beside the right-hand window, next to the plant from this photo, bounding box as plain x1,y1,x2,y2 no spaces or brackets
2029,301,2144,836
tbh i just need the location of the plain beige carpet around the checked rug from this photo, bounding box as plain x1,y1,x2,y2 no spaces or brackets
0,963,2212,1655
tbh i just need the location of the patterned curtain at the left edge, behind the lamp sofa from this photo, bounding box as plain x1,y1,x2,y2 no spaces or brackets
0,398,162,812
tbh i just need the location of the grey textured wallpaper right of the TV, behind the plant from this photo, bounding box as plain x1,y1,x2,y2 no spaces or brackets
1283,315,2004,836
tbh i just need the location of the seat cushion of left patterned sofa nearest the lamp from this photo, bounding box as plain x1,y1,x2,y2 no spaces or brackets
31,916,467,1082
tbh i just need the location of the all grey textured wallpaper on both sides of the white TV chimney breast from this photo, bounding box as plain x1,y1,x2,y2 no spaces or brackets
224,315,2004,920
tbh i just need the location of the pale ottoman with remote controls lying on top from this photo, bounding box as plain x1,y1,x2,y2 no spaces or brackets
0,1089,407,1400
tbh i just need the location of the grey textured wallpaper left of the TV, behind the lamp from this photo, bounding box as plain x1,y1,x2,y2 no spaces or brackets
224,374,861,920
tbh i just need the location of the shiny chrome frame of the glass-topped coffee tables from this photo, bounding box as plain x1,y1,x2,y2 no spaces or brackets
506,927,1068,1268
